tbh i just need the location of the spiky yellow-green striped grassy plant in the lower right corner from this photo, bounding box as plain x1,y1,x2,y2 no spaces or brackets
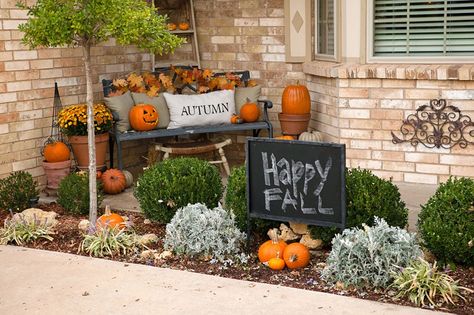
390,258,474,308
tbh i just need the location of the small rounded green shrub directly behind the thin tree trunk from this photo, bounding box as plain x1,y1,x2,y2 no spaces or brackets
58,172,104,214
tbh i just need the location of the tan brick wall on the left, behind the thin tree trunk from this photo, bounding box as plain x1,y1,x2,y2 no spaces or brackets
0,0,151,184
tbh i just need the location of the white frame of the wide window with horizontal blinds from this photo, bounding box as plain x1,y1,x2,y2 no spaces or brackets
366,0,474,64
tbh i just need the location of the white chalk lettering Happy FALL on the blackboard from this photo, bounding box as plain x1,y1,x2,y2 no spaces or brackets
262,152,334,215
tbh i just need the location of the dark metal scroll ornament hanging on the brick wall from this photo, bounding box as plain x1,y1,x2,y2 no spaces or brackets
392,99,474,149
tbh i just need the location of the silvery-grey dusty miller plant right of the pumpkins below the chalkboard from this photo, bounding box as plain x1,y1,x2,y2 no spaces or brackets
322,217,422,287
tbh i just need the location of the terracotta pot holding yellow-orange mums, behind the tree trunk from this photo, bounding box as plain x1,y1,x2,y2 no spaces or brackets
68,133,109,170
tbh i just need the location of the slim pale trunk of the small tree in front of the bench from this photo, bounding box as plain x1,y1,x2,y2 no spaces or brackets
83,44,97,226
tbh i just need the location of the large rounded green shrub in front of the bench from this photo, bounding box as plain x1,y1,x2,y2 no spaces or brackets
133,158,223,223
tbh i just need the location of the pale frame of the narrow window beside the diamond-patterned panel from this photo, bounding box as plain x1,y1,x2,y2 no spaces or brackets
313,0,342,62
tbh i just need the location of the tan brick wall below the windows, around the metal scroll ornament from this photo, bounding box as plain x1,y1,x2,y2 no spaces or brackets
304,62,474,184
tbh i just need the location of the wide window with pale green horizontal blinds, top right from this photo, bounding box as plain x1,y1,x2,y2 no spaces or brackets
368,0,474,58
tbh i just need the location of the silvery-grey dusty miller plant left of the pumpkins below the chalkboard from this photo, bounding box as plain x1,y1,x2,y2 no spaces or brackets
164,203,245,262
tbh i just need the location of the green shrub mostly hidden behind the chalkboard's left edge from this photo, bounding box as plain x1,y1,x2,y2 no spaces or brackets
225,166,280,233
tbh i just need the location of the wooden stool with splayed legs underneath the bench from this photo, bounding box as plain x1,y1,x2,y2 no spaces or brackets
155,139,232,176
